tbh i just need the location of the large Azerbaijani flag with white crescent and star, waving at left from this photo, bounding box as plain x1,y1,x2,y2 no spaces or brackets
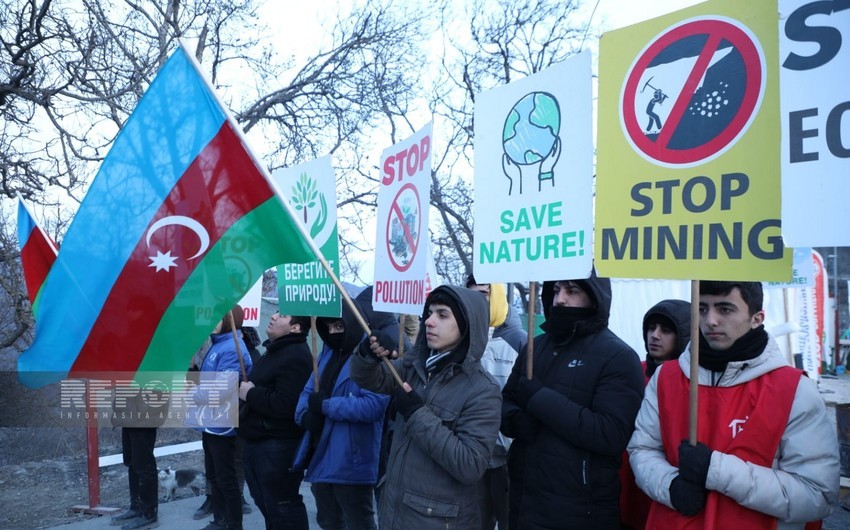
18,47,319,388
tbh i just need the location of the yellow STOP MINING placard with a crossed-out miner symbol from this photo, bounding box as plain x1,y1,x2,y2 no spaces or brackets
594,0,792,281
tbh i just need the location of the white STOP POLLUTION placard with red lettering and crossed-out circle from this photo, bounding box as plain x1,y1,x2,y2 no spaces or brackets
372,122,432,315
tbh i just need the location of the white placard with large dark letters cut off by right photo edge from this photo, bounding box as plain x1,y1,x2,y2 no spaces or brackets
779,0,850,247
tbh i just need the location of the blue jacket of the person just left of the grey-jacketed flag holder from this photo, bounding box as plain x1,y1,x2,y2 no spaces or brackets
293,347,389,486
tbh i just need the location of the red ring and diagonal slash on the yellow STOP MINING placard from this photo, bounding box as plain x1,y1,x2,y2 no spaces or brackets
620,18,765,166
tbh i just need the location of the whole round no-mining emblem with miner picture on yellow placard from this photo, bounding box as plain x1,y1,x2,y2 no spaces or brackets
620,17,766,167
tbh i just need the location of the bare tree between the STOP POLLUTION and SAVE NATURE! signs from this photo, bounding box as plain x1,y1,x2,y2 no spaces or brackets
424,0,586,307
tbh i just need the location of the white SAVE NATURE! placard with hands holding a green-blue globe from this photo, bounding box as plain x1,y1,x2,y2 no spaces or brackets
473,52,593,283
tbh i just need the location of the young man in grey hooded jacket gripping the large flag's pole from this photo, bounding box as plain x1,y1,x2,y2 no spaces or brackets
351,286,501,530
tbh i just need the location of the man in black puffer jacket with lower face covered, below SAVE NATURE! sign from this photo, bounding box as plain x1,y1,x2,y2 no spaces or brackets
502,271,644,530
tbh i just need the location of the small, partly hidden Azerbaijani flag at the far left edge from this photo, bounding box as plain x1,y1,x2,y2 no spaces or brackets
18,194,58,313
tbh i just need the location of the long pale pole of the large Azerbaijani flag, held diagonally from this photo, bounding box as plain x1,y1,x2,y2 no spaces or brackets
177,39,404,386
